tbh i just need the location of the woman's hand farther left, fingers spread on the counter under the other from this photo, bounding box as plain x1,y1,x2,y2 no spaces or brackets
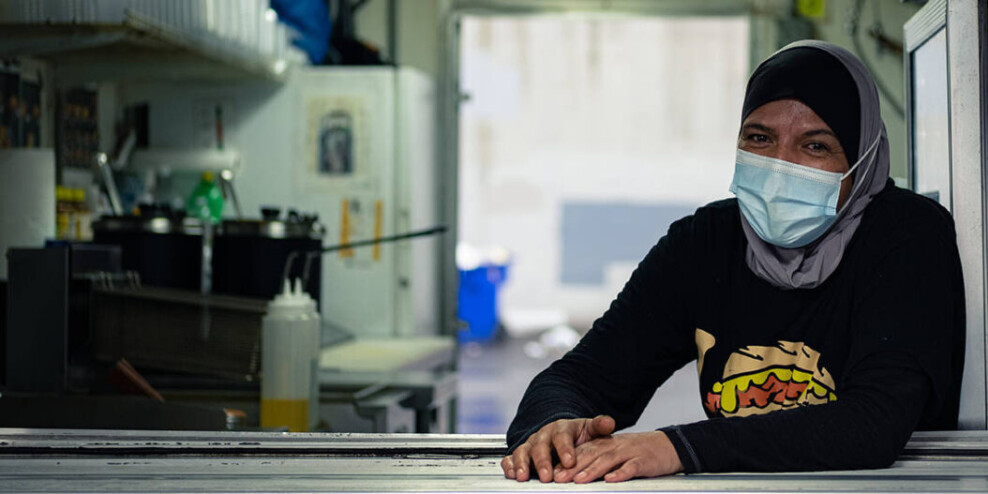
501,415,612,482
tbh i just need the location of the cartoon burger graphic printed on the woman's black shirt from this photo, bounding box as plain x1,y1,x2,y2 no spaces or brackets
697,330,837,417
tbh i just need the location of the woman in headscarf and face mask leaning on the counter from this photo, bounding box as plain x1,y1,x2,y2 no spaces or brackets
502,41,964,482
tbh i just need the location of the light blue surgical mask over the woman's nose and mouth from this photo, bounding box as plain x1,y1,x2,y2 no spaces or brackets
730,146,874,248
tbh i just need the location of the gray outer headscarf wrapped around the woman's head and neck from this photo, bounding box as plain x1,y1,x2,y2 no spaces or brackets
739,40,889,289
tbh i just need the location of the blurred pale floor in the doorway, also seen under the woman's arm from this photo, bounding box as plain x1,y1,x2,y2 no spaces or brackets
456,338,705,434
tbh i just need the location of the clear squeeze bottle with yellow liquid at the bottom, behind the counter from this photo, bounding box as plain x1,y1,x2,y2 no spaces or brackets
261,280,321,432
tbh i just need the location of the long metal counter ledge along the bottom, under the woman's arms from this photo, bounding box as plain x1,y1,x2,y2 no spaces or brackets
0,429,988,492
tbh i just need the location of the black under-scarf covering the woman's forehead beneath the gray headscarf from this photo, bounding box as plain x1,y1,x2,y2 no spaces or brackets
741,47,861,165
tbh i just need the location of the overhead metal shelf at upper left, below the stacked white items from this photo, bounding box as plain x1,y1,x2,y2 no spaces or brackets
0,10,289,84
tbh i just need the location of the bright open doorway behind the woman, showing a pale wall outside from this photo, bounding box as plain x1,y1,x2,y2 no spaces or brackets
457,15,750,433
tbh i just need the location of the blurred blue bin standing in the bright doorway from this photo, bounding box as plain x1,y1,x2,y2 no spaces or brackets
456,264,508,343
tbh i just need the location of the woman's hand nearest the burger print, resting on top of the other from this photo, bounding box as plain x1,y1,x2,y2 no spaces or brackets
553,431,683,484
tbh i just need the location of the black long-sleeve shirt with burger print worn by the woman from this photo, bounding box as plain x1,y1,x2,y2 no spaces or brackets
507,182,964,473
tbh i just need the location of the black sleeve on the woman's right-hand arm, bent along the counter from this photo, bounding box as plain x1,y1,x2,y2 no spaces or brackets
662,215,964,473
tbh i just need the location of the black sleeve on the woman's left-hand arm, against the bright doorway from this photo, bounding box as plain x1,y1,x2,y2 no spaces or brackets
507,217,696,452
